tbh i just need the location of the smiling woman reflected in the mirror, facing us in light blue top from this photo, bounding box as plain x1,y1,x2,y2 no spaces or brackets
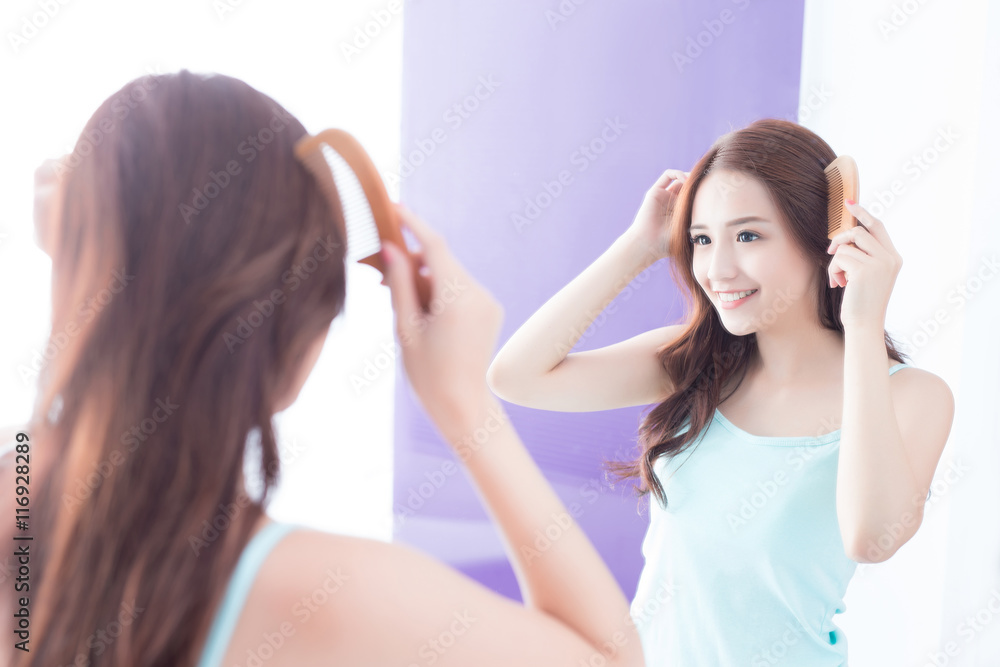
487,119,954,667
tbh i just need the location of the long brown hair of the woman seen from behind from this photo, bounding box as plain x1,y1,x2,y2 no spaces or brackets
4,70,346,667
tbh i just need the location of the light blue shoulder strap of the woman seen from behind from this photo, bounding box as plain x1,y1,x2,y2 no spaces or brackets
198,521,301,667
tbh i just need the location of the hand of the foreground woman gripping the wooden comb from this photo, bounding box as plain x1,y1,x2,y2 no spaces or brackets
382,204,503,432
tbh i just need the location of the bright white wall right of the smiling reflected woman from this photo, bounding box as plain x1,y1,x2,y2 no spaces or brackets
799,0,1000,667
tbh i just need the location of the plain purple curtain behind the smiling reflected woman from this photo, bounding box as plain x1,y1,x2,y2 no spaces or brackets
393,0,803,600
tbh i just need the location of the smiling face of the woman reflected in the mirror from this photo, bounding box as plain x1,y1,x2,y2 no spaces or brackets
689,170,818,336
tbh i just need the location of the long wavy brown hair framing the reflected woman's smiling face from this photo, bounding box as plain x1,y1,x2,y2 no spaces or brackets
605,118,903,507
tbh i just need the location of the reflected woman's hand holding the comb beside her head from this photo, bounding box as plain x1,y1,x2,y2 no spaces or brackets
827,202,903,331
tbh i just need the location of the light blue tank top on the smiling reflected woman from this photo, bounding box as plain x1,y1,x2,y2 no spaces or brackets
630,364,908,667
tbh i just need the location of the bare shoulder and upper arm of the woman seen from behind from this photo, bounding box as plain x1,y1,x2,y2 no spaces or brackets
247,530,616,667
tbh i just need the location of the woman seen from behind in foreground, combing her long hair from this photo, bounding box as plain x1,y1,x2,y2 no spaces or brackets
0,70,644,667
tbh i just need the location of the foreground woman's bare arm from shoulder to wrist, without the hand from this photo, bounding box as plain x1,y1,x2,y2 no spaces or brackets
295,397,645,667
